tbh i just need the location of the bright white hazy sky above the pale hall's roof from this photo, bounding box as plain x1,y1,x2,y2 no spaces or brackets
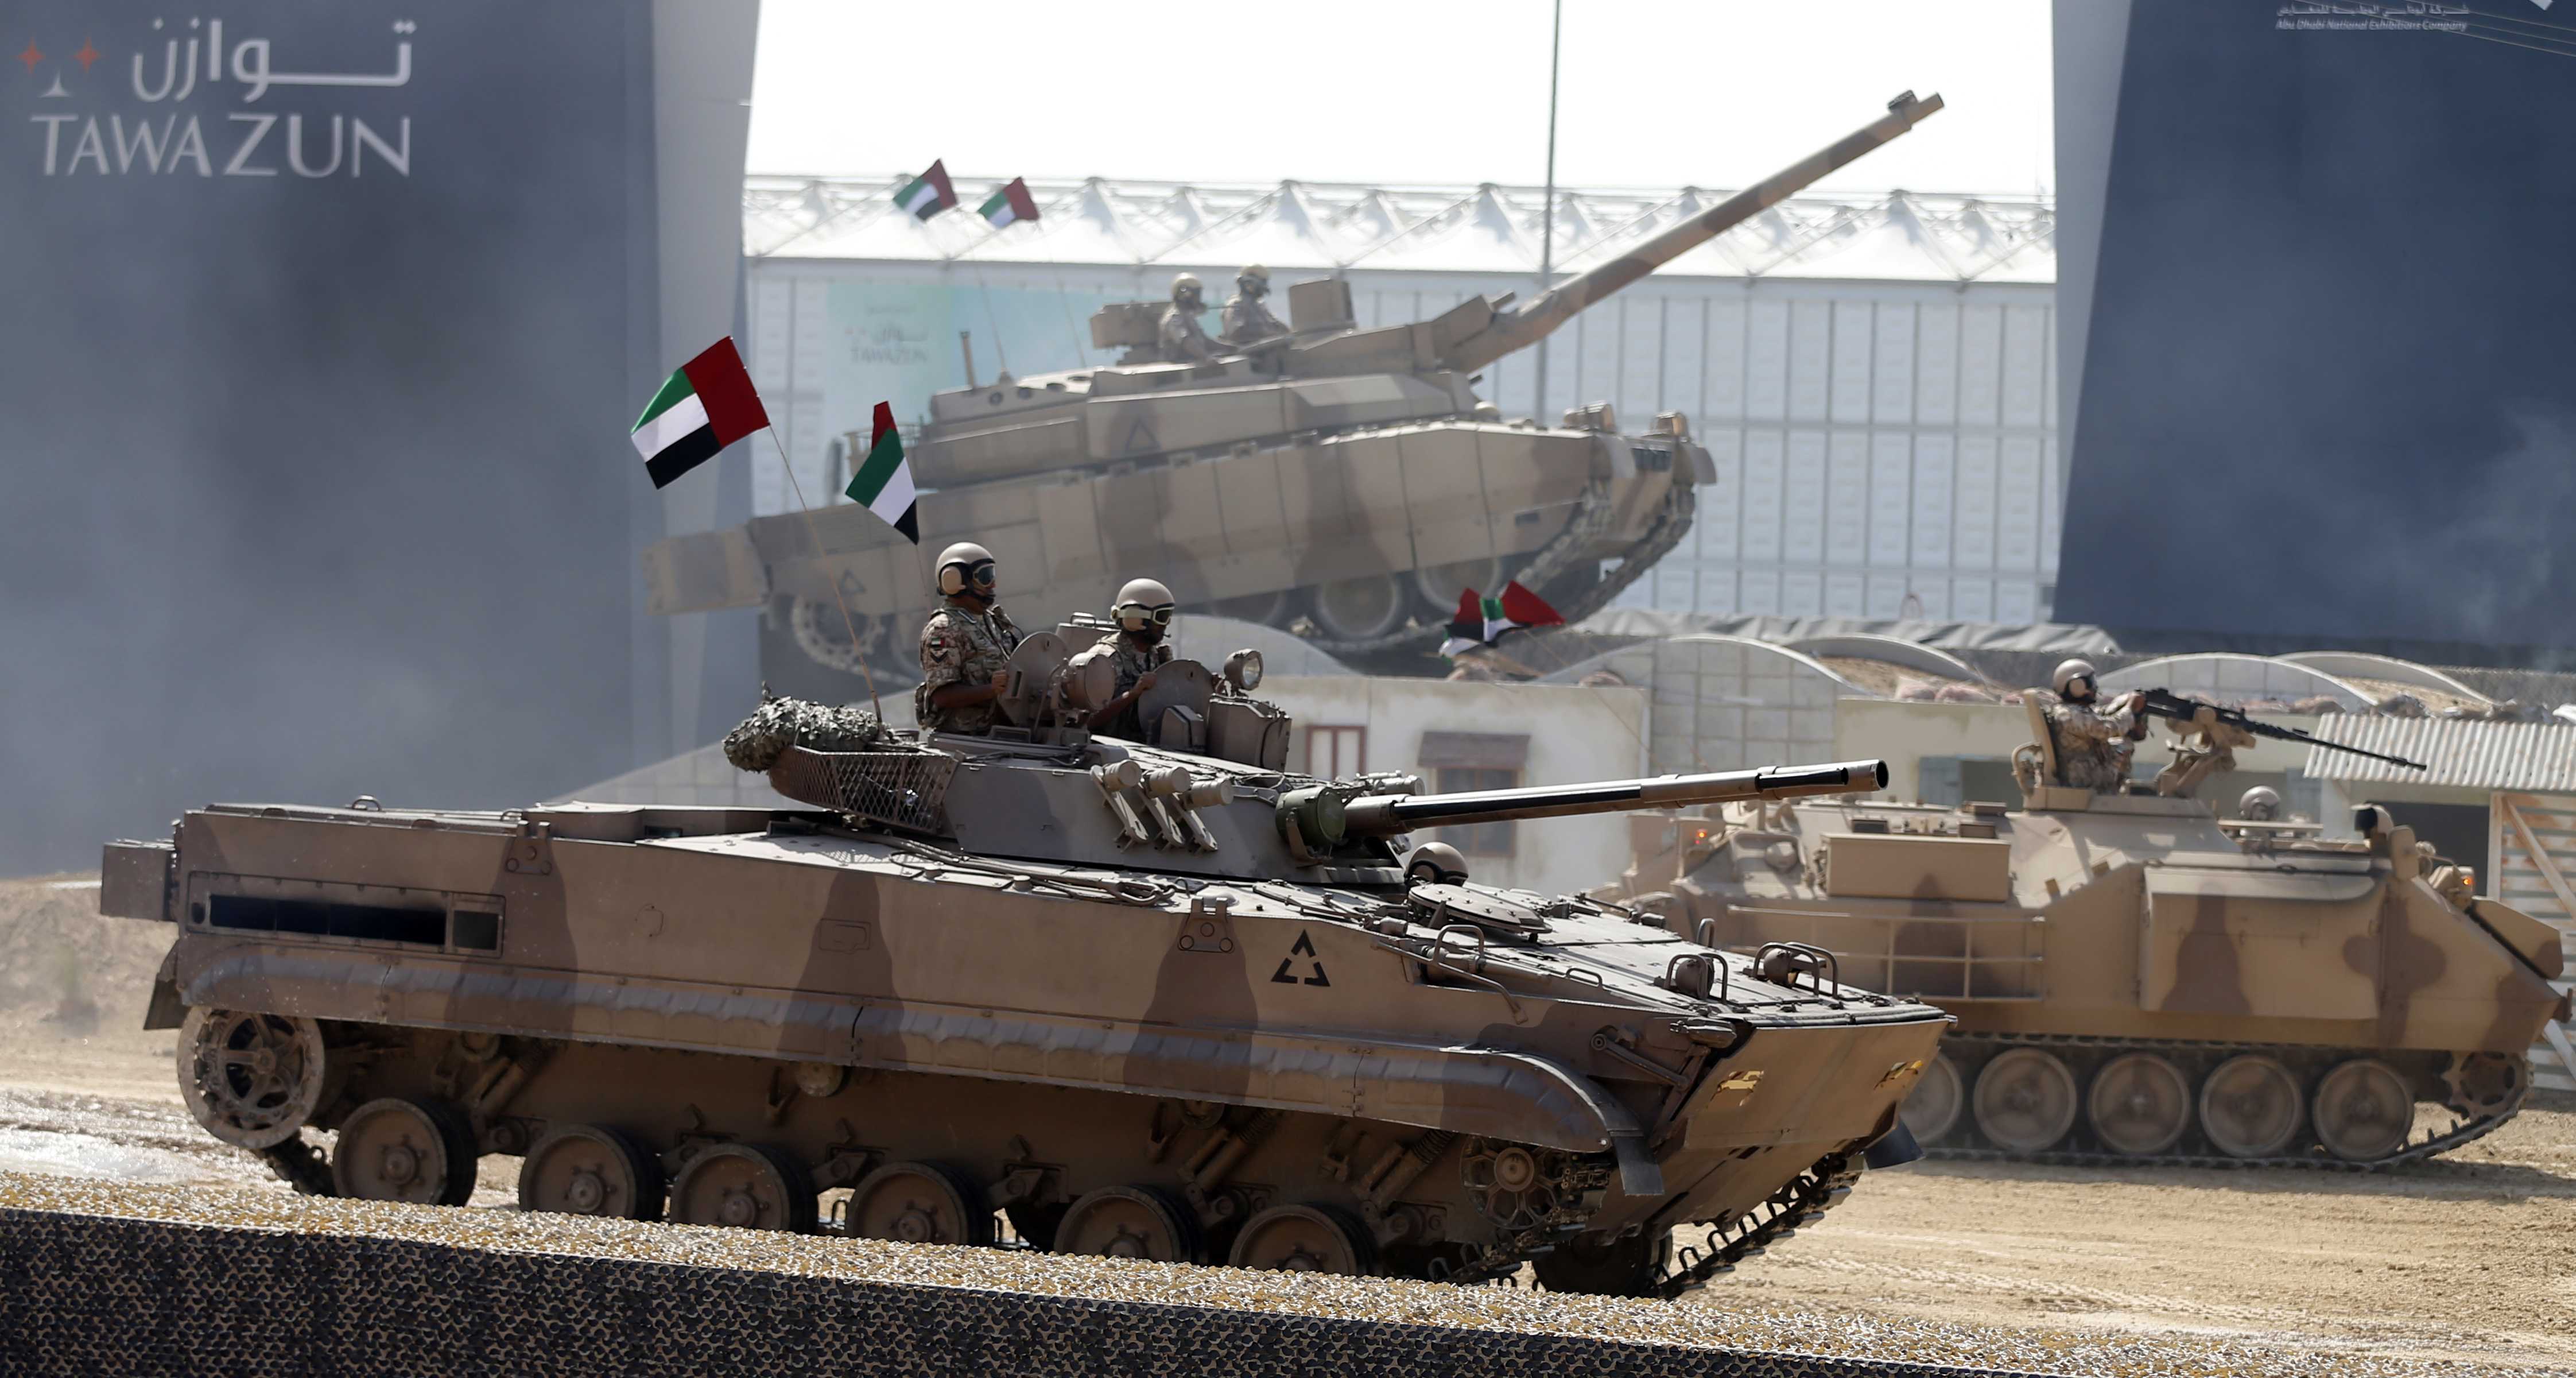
750,0,2055,193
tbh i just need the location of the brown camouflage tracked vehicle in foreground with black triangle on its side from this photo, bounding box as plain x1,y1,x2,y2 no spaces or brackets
100,641,1945,1295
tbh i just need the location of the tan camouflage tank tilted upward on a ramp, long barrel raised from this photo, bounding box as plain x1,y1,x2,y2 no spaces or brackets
644,92,1942,698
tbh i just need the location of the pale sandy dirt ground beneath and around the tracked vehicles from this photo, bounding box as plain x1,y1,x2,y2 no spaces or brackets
0,876,2576,1371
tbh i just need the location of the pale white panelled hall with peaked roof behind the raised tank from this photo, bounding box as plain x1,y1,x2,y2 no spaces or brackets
744,175,2066,624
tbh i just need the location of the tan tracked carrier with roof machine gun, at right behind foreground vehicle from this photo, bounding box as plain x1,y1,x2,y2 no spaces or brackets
1595,698,2569,1167
